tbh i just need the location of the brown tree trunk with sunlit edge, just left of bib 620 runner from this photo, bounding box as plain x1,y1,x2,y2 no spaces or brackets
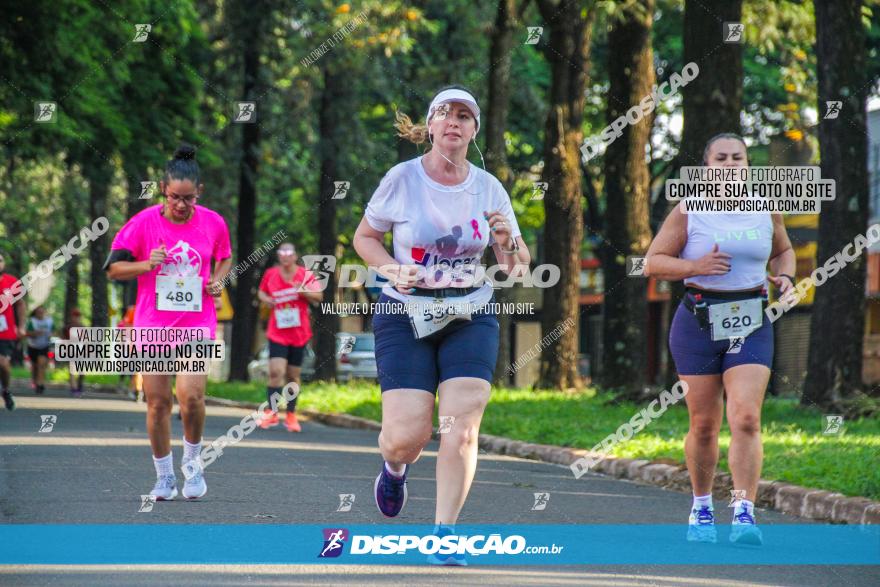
600,0,654,397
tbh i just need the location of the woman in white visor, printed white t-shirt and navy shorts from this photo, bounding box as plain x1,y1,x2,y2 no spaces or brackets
354,86,530,560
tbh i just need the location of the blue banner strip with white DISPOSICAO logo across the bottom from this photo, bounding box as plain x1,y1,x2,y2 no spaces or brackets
0,524,880,566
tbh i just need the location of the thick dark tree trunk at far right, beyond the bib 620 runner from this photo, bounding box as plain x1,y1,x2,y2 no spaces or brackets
801,0,871,408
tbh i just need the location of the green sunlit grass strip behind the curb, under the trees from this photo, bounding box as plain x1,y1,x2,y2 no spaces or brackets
209,383,880,499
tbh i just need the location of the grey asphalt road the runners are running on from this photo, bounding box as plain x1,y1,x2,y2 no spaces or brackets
0,390,880,586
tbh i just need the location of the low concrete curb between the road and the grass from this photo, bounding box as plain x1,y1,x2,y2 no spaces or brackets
27,384,880,524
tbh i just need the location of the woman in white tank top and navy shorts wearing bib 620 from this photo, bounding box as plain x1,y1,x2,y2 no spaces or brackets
645,134,795,544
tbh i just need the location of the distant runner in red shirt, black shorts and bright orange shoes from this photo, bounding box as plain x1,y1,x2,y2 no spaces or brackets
257,243,323,432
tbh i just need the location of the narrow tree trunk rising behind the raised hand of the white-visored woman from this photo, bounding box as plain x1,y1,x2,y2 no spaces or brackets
484,0,516,386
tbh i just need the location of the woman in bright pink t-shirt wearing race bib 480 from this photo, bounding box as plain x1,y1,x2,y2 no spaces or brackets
104,144,232,500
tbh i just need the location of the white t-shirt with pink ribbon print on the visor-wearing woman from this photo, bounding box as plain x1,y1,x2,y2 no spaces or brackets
365,157,522,305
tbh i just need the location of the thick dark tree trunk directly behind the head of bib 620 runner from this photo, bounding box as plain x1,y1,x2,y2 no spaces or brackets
664,0,743,386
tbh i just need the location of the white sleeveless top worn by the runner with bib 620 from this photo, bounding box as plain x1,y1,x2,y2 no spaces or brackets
679,214,773,291
